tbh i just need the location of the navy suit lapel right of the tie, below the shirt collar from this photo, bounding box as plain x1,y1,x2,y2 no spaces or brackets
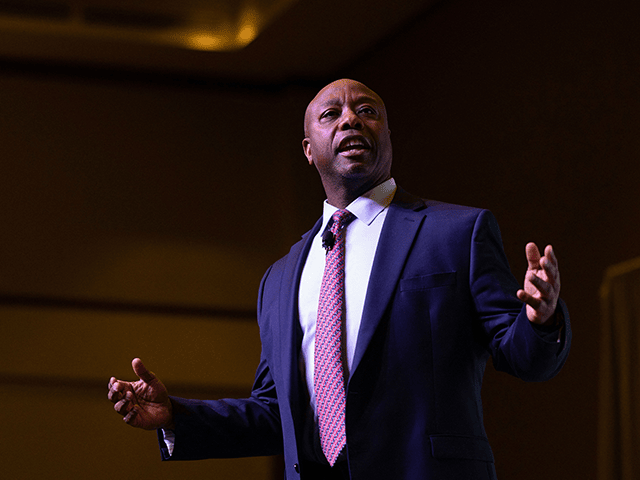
352,188,425,375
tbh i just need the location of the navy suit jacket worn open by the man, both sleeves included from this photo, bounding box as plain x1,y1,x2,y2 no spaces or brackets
161,189,571,480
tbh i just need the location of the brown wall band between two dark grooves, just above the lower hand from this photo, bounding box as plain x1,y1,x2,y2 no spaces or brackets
0,307,260,391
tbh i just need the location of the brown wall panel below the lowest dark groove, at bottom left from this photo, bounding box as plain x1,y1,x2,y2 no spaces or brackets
0,384,274,480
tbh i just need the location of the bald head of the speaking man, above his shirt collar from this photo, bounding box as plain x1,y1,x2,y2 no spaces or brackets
302,79,392,208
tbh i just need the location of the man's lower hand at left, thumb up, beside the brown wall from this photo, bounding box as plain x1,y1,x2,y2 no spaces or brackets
107,358,173,430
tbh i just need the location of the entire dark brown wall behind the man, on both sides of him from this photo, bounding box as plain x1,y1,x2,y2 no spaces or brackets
0,0,640,480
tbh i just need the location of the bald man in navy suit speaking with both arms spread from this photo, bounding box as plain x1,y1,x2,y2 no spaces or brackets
109,80,571,480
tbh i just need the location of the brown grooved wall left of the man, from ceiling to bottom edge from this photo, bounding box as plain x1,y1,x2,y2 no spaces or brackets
0,68,312,479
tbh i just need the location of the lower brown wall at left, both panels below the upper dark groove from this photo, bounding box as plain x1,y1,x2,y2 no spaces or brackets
0,306,278,480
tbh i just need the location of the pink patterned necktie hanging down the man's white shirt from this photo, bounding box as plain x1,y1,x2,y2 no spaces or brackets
313,210,355,466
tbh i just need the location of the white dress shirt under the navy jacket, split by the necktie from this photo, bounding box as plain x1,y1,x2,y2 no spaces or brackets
298,178,396,415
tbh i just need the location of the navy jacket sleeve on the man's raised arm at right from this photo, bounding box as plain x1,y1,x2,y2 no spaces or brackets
469,210,571,381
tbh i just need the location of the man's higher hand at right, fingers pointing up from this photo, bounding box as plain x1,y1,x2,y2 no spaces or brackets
516,243,560,325
